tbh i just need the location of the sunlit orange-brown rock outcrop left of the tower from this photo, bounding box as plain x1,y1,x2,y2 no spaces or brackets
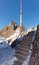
0,21,18,38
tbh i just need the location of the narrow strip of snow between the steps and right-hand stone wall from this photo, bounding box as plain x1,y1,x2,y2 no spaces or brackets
22,31,36,65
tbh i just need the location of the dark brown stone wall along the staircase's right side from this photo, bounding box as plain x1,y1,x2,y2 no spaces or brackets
29,26,39,65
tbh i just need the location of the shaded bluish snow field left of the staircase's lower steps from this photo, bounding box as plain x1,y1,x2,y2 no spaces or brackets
0,43,17,65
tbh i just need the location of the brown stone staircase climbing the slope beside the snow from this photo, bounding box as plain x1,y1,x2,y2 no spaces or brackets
14,32,35,65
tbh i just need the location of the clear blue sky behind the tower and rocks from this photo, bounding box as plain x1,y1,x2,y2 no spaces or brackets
0,0,39,29
